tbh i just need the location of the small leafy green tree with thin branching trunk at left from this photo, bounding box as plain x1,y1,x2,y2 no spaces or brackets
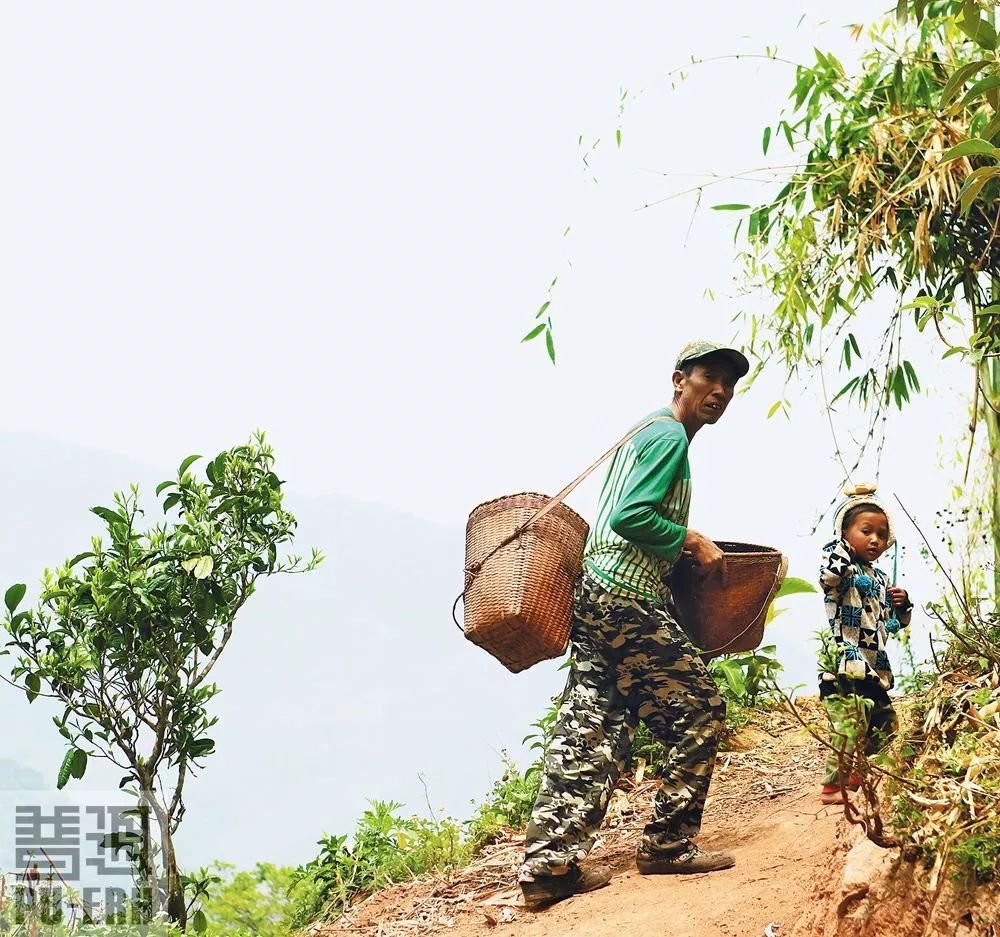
3,433,322,928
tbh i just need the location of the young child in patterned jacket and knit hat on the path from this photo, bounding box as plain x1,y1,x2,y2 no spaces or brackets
819,485,913,804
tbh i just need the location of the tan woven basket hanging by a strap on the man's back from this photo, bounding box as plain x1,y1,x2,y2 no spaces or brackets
464,492,588,673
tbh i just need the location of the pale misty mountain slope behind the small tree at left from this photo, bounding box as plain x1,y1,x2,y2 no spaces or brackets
0,437,563,866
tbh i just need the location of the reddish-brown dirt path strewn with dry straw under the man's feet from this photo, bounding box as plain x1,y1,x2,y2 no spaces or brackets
322,713,854,937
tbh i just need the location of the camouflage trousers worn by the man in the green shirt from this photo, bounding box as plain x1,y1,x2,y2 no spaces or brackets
520,576,726,881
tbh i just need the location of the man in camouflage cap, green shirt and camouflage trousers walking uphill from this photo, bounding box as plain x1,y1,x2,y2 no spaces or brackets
519,342,750,909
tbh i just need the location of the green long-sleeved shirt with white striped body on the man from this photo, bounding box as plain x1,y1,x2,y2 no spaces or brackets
583,408,691,602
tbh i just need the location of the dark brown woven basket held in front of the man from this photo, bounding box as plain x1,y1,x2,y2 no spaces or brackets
670,541,788,656
